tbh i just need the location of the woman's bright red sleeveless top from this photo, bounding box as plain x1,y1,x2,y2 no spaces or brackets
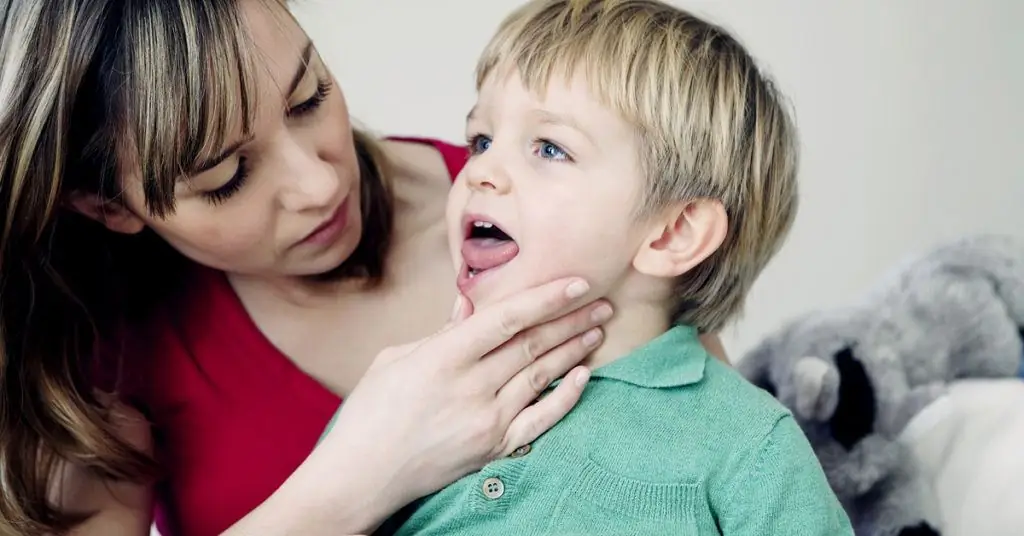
110,138,468,536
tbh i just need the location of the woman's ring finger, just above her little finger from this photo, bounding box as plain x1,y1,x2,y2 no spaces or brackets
498,328,603,422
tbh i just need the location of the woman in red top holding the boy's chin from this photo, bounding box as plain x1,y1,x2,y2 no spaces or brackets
0,0,720,536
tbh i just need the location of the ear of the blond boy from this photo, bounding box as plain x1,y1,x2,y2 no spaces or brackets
633,199,729,278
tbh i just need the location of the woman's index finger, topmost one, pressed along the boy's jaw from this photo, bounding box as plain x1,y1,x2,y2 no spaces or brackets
434,278,596,362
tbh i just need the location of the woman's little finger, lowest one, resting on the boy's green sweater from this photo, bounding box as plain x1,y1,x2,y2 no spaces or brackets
495,367,590,458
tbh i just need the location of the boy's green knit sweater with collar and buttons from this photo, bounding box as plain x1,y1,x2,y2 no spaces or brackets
387,327,853,536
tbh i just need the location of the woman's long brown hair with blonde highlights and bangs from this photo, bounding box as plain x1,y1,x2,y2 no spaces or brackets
0,0,391,535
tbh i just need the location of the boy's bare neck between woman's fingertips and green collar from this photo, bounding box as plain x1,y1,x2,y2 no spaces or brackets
583,301,670,370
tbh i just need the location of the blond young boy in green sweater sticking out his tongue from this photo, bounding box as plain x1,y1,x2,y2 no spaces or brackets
382,0,853,536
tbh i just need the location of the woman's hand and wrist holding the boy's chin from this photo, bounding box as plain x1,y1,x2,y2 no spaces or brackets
243,279,611,534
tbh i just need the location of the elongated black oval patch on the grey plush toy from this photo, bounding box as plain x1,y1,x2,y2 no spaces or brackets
828,346,878,450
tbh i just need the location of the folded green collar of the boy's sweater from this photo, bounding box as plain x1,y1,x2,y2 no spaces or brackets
591,326,708,388
